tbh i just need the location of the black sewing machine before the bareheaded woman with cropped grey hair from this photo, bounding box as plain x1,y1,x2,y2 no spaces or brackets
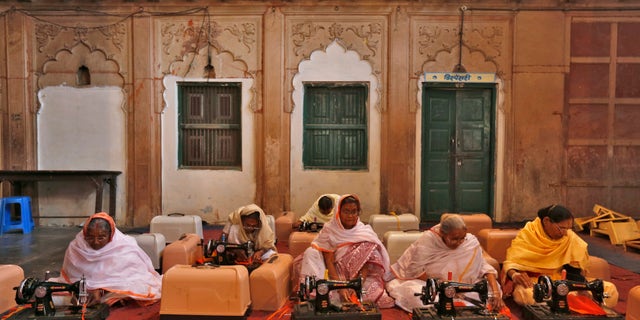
413,278,508,320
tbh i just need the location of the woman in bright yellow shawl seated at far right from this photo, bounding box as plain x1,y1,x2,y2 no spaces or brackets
501,205,618,308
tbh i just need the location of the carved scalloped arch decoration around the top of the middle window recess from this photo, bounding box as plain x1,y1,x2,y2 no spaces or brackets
284,17,388,113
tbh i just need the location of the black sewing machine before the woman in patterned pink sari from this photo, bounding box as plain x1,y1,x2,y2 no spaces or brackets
291,277,382,320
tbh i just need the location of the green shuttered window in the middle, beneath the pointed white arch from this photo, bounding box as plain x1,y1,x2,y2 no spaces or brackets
302,83,368,170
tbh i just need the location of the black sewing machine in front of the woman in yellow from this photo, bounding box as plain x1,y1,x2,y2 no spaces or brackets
524,276,623,320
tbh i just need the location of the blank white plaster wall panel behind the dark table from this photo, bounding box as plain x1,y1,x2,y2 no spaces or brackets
37,86,126,225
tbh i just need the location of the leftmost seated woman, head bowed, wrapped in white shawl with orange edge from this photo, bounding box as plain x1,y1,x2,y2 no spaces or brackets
54,212,162,306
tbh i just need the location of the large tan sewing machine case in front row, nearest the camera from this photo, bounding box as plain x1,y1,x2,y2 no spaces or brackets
160,265,250,319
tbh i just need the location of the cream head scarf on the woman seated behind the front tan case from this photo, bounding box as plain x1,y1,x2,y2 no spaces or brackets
223,204,276,250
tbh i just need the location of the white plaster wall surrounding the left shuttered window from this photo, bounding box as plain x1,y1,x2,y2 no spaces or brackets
162,76,256,223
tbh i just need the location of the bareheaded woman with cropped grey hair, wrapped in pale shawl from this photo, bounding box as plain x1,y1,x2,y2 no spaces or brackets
387,215,504,312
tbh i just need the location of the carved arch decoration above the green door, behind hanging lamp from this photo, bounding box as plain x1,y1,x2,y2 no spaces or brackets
410,16,512,112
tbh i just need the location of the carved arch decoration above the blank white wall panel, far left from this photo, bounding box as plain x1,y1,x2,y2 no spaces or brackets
34,21,128,108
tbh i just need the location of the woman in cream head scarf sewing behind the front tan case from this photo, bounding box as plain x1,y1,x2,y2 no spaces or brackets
222,204,277,264
